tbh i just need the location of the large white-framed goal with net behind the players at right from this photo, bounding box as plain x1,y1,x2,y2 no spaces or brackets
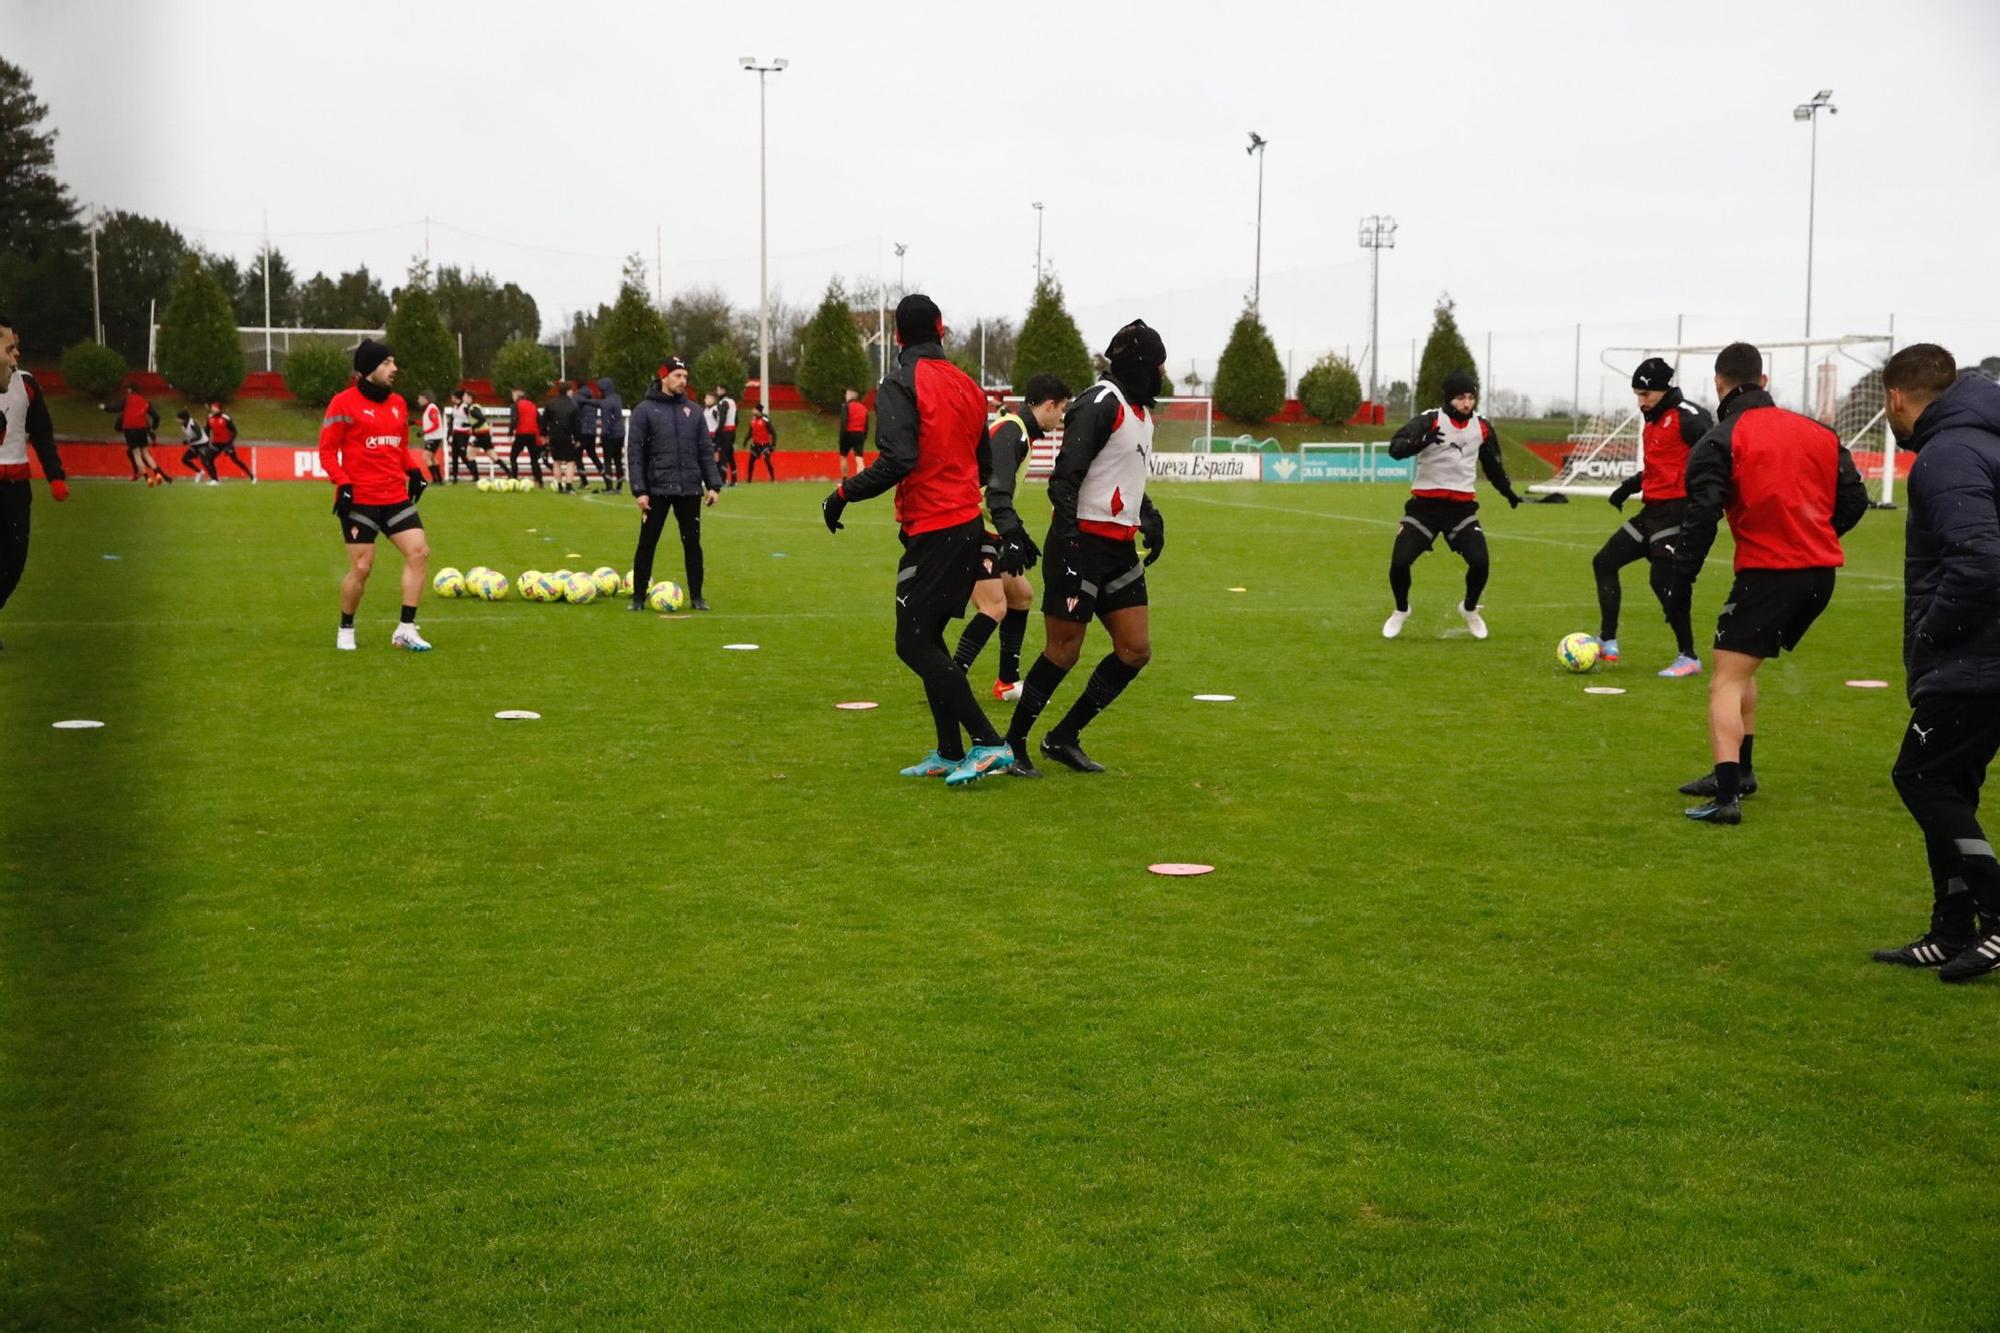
1528,334,1908,508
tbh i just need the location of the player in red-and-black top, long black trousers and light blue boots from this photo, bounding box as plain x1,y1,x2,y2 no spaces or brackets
820,292,1014,787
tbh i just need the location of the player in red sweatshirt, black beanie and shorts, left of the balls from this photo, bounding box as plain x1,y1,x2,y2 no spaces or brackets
320,338,430,652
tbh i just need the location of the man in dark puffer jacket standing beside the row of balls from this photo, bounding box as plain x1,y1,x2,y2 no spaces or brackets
626,356,722,610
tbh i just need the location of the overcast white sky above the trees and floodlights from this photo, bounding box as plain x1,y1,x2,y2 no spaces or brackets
0,0,2000,402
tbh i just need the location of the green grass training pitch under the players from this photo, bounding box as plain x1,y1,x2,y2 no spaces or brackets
0,482,2000,1329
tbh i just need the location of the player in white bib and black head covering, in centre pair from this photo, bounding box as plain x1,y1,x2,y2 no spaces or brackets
1000,320,1166,777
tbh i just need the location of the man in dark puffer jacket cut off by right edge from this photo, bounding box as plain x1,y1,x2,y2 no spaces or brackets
1874,342,2000,981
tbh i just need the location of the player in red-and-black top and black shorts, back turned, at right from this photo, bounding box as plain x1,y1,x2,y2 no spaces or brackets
1674,342,1868,825
